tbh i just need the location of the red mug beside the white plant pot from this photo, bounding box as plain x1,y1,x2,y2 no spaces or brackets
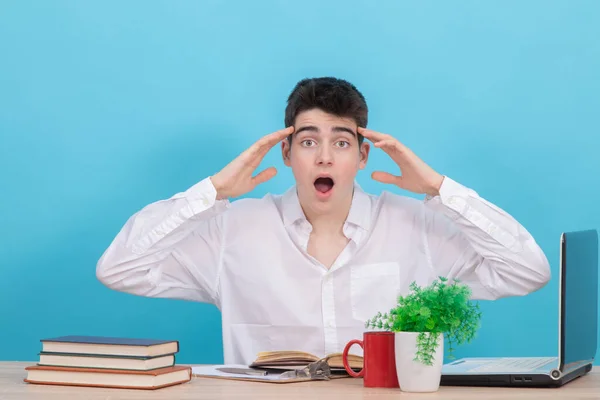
342,332,400,388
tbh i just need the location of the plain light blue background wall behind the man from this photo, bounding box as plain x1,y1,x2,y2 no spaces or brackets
0,0,600,363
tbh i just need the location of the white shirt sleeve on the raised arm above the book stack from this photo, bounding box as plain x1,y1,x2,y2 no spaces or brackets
96,178,229,305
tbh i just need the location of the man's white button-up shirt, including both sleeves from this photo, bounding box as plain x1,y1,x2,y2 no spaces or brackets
97,177,550,364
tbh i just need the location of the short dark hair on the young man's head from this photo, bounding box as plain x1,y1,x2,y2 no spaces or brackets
285,77,369,143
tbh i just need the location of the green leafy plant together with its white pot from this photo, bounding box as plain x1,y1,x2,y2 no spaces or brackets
365,277,481,392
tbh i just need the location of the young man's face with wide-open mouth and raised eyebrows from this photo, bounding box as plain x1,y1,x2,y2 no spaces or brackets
282,109,369,212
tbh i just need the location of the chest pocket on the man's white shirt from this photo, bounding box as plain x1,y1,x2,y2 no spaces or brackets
350,262,400,323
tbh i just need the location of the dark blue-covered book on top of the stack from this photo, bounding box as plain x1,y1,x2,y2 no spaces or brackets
41,336,179,358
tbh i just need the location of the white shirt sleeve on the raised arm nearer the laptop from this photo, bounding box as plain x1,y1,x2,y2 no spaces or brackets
425,177,550,300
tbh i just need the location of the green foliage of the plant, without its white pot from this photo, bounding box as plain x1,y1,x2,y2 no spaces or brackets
365,277,481,365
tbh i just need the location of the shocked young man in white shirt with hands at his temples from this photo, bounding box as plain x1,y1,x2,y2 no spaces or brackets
97,78,550,364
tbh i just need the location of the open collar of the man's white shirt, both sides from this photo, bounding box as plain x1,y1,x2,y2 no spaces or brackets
281,182,371,230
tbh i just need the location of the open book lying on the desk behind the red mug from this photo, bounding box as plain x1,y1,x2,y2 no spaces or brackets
250,351,363,370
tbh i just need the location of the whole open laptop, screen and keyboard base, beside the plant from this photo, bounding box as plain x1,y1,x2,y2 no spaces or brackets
441,230,598,387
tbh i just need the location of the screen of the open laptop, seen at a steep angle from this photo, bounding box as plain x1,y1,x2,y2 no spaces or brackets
560,230,598,371
